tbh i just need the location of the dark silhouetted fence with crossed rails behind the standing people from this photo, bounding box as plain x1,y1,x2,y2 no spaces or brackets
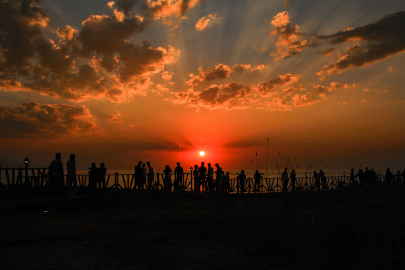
0,167,395,194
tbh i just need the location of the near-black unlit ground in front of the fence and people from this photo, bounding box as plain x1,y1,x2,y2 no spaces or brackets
0,186,405,269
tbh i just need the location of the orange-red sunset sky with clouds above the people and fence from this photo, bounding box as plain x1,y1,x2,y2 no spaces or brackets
0,0,405,172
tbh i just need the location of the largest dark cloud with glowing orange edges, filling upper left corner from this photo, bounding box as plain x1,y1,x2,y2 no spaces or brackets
0,0,179,102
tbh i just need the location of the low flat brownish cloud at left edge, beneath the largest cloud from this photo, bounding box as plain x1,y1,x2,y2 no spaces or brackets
0,102,99,139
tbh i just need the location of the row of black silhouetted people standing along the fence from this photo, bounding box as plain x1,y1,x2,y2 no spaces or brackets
48,153,405,197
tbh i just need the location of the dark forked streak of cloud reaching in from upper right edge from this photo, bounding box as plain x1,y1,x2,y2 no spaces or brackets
317,11,405,74
